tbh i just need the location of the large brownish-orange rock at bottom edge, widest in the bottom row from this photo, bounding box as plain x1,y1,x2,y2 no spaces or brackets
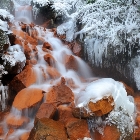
28,118,67,140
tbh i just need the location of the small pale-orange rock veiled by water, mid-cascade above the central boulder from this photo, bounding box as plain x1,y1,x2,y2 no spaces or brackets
46,66,61,79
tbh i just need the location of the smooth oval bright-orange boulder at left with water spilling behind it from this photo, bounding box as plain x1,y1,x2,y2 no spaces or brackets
13,88,43,110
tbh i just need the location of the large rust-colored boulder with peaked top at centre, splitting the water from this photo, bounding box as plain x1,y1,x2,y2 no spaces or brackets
46,84,74,105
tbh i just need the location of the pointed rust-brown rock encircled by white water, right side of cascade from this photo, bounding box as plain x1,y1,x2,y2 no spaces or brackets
65,55,78,71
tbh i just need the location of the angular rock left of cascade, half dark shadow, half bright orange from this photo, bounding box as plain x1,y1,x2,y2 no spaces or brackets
10,65,36,92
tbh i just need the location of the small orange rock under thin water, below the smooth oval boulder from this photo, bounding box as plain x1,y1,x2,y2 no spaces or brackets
6,115,29,128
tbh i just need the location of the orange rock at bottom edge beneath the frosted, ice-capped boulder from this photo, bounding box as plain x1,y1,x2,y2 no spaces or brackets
94,125,120,140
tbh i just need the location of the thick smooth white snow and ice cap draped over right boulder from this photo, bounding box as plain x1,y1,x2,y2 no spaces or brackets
75,78,134,116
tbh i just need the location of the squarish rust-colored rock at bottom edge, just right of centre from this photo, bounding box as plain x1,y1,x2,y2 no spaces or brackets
66,119,90,140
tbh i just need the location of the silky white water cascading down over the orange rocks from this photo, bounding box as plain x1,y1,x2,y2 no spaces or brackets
0,3,94,140
